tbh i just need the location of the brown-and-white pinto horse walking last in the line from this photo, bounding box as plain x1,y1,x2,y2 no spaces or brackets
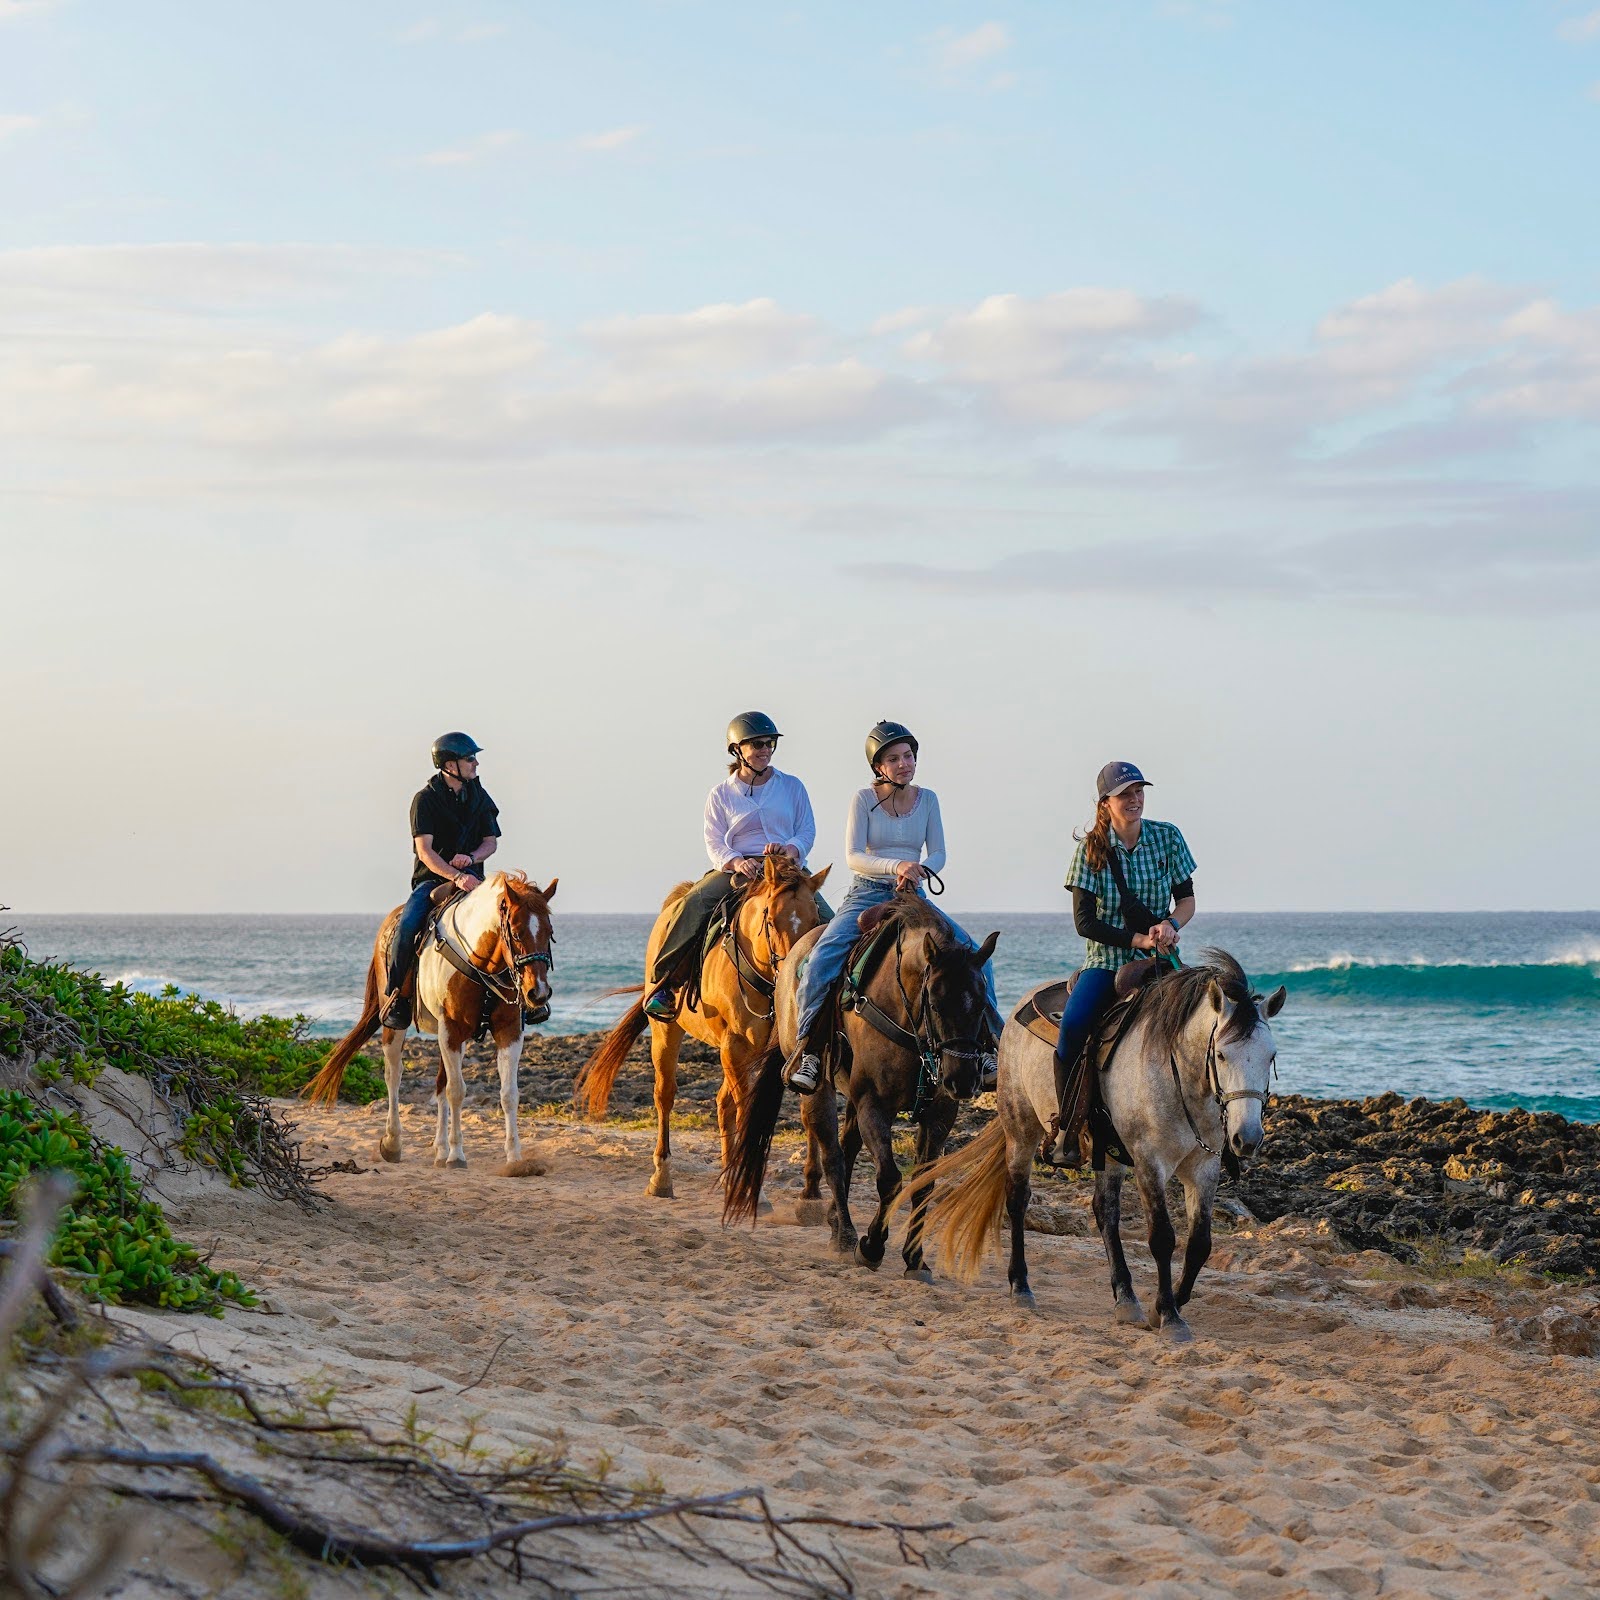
301,872,557,1170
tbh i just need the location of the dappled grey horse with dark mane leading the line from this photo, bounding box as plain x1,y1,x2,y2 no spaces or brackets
918,950,1285,1342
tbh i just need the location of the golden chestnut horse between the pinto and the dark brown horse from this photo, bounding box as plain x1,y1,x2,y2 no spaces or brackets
573,854,832,1200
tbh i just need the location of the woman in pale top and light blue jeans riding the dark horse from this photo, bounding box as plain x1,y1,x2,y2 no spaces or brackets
787,722,1002,1094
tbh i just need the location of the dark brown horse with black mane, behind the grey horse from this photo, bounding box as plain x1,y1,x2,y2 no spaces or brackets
723,893,1000,1278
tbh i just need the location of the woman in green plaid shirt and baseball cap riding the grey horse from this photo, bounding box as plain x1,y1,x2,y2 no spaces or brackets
1053,762,1195,1160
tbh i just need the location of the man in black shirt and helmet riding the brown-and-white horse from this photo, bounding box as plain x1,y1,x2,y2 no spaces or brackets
382,733,499,1027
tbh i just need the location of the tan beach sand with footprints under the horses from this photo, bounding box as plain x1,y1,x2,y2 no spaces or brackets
106,1066,1600,1600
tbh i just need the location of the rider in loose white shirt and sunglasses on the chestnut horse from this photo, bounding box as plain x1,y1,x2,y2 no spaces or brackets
645,710,827,1022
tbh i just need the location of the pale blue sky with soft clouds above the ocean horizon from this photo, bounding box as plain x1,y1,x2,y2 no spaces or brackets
0,0,1600,914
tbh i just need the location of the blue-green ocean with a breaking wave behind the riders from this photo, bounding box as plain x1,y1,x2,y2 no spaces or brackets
12,910,1600,1122
